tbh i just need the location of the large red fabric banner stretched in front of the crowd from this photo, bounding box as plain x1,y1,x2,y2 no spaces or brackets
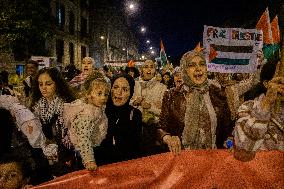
34,150,284,189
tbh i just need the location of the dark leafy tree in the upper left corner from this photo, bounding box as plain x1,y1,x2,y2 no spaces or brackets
0,0,52,60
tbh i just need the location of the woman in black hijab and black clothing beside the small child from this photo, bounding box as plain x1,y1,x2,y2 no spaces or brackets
101,74,142,162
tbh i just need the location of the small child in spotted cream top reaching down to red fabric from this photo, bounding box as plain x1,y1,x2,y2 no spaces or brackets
63,71,110,170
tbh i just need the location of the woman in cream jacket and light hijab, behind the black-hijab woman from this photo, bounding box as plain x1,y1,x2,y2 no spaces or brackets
130,60,167,156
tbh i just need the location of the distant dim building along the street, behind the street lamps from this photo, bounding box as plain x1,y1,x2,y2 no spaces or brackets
89,0,138,65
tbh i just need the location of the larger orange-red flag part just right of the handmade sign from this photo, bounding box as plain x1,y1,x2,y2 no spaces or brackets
256,8,273,44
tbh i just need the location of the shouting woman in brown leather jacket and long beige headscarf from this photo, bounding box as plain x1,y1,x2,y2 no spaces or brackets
158,50,232,154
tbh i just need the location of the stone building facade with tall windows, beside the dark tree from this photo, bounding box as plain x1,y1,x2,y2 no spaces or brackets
47,0,91,66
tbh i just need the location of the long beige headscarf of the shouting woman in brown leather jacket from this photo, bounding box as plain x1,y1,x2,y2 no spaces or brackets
181,50,217,149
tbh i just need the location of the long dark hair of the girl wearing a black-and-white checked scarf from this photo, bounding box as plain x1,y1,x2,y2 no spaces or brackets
30,68,76,107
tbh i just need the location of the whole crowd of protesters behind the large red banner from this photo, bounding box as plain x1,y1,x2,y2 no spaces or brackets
0,44,284,188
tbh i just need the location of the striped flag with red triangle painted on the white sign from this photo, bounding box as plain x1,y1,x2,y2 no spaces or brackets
209,44,253,65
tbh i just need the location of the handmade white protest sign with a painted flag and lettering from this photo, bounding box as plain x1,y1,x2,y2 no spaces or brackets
203,26,263,73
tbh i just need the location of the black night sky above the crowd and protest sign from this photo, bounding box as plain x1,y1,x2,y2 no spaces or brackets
116,0,281,62
